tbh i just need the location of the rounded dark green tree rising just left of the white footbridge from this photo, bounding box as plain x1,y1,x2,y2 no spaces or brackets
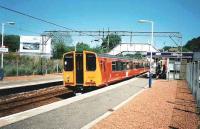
101,34,121,51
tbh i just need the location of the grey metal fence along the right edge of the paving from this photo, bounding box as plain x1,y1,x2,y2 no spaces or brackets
186,61,200,108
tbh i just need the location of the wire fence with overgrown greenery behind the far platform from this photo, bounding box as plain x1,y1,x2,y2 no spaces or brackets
3,54,63,76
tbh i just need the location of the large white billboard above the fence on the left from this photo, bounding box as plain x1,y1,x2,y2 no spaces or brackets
19,36,52,58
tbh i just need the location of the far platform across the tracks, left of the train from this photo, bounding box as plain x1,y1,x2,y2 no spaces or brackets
0,74,62,90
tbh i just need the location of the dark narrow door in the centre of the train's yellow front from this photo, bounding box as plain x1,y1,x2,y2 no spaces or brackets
76,53,83,85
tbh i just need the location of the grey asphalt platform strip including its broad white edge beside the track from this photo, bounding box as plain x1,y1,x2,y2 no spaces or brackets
0,78,148,129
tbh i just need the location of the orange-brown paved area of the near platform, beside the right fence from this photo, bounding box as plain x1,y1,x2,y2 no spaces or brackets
92,80,200,129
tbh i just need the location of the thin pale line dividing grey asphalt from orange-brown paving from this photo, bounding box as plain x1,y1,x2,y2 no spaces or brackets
81,85,148,129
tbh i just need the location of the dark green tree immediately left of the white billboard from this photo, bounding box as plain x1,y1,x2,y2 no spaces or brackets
0,35,20,52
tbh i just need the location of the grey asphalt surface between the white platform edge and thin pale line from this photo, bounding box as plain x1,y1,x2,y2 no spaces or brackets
1,78,148,129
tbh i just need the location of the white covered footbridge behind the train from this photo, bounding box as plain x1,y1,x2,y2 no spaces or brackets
108,43,159,55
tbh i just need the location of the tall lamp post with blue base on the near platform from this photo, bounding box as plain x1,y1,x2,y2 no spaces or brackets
138,20,154,88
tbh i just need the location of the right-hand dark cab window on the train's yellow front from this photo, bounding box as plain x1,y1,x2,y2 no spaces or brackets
86,53,96,71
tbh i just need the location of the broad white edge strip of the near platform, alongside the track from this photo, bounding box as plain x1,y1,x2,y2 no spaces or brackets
0,75,147,127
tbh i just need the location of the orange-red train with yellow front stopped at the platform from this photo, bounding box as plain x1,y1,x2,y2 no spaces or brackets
63,51,149,90
